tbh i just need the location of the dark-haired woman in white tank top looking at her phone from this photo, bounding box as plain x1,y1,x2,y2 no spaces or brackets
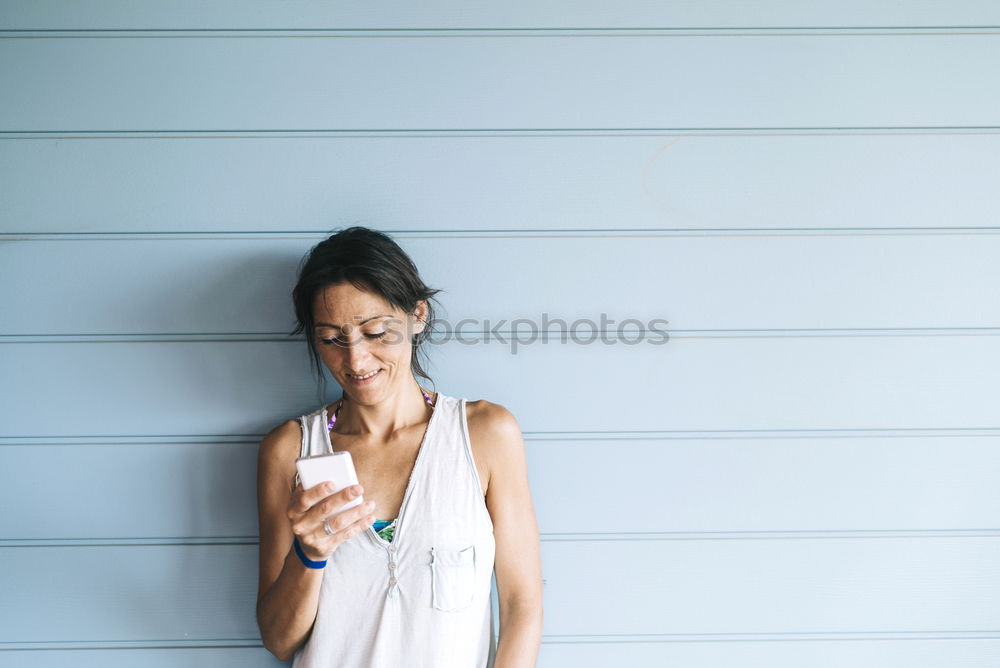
257,227,542,668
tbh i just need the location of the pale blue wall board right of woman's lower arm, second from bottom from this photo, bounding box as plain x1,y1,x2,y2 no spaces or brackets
543,538,1000,636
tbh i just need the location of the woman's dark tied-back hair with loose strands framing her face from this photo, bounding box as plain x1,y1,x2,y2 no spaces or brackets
292,226,441,401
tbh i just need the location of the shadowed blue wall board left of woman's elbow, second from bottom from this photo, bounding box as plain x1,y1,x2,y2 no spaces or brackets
0,545,260,647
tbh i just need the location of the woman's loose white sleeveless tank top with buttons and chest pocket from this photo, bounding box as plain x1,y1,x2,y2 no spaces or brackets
292,392,496,668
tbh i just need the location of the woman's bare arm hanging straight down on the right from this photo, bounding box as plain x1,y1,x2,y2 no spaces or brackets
469,401,543,668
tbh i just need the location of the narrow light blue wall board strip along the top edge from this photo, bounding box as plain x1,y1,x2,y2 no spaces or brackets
0,0,1000,30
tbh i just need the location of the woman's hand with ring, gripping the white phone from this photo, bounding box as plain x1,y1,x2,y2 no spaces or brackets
287,482,375,561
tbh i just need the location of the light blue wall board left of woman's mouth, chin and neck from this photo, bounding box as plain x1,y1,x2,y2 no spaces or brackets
0,341,316,438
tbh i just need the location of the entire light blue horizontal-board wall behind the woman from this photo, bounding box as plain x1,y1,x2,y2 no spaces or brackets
0,0,1000,668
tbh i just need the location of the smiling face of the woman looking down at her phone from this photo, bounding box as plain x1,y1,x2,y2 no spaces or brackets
313,283,425,405
